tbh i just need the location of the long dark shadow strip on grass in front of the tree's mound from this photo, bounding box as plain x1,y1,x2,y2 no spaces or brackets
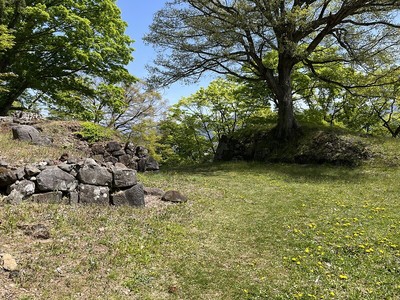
155,162,366,183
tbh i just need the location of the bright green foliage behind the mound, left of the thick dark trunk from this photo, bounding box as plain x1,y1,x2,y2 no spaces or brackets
160,78,271,163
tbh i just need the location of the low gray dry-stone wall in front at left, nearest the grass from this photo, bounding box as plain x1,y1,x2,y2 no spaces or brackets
0,158,145,207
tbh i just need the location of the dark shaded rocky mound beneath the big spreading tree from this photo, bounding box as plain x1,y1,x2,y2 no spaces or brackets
216,126,394,166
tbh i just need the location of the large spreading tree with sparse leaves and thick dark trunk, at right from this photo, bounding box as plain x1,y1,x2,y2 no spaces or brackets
145,0,400,139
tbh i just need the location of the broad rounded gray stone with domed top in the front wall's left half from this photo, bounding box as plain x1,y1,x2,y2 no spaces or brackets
36,166,78,192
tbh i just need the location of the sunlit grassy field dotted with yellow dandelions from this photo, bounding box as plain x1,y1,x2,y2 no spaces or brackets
0,132,400,299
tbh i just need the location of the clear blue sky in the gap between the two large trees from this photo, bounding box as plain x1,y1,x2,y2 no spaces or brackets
117,0,210,104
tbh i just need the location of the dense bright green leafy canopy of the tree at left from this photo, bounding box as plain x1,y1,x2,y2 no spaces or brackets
0,0,133,115
